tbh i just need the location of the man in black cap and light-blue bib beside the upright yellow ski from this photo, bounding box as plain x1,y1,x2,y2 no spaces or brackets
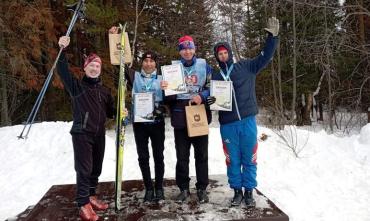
126,51,165,202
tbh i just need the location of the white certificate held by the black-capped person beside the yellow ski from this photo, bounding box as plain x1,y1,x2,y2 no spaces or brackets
134,93,154,122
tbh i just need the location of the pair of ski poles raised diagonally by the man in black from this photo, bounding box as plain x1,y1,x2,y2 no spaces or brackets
18,0,85,139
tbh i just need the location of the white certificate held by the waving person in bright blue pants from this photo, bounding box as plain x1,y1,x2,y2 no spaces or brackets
210,80,233,111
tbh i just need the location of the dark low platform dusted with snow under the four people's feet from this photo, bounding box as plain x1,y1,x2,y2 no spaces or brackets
12,176,289,221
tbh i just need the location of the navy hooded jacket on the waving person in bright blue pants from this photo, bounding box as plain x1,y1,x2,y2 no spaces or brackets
212,34,278,124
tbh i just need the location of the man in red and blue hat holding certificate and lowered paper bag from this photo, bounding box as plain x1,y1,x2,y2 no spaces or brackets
161,36,212,203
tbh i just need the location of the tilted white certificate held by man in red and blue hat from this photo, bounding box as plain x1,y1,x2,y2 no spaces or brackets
161,64,188,96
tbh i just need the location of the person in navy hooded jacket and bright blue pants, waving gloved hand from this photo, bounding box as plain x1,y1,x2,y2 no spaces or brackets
207,18,279,206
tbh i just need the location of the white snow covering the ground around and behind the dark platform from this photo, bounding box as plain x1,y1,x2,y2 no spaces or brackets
0,118,370,221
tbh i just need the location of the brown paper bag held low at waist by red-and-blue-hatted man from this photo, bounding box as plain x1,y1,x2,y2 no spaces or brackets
185,102,209,137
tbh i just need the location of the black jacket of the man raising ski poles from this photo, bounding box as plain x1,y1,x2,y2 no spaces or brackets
57,53,115,136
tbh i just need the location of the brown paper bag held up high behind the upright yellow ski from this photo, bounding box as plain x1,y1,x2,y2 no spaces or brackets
109,32,132,65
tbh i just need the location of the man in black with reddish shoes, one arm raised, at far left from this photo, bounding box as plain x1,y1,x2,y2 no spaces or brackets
57,36,115,220
